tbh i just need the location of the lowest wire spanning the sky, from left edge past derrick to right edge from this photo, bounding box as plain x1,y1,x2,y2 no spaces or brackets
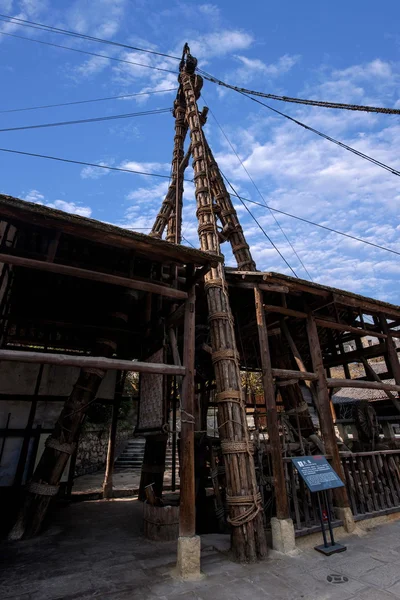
0,148,400,256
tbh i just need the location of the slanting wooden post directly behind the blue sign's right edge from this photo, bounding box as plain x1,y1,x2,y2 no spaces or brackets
307,313,350,508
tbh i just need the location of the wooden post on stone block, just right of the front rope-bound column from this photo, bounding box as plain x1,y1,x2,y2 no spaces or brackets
254,285,290,519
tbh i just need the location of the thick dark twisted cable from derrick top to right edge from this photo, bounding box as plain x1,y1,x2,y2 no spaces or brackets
197,69,400,115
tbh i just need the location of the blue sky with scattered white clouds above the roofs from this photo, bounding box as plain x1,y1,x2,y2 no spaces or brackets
0,0,400,303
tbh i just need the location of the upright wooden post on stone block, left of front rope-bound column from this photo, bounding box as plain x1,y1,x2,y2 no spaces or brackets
179,287,196,537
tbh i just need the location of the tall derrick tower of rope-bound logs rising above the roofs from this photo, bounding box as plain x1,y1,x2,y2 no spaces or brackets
151,45,268,561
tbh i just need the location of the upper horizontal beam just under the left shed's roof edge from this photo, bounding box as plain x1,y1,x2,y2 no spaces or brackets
0,254,187,300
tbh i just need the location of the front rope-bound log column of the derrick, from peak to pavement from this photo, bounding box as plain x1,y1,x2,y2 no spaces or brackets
181,55,267,561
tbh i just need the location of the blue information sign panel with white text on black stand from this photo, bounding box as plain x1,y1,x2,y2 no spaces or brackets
292,456,344,492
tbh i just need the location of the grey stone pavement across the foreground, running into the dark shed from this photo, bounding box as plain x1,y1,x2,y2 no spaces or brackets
0,499,400,600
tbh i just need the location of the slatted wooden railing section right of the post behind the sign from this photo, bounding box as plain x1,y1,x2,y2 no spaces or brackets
341,450,400,519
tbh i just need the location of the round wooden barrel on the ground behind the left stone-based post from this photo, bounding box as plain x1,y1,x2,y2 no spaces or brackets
143,502,179,542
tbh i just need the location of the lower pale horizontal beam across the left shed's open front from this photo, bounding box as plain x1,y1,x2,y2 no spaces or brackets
0,350,186,375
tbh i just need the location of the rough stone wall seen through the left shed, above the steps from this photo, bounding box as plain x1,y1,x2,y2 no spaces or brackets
75,423,133,477
